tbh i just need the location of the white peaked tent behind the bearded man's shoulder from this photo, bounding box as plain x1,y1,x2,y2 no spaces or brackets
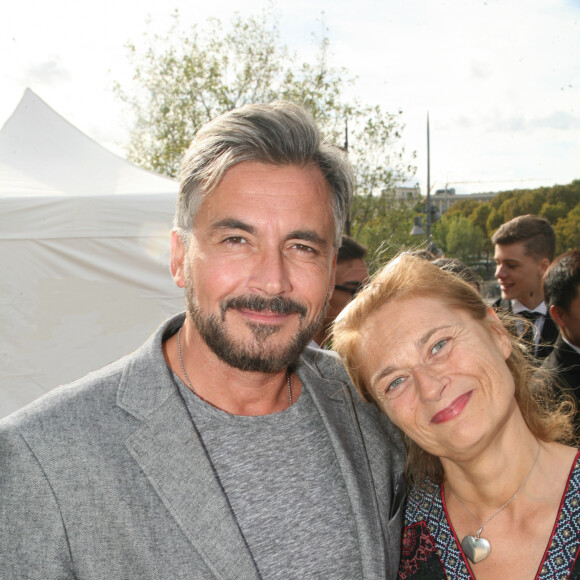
0,89,183,417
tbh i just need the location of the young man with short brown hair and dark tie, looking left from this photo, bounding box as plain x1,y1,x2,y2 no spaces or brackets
491,215,558,360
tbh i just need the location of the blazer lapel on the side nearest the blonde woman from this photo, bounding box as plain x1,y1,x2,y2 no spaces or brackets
298,365,386,579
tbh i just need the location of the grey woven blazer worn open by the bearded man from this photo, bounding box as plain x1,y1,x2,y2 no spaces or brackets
0,314,405,580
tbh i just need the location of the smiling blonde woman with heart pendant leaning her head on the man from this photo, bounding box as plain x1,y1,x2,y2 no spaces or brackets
333,254,580,580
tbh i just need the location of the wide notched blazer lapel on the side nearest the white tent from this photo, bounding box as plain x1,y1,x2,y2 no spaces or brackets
117,315,258,580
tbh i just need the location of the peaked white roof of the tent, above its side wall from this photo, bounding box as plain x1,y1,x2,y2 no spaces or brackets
0,89,177,197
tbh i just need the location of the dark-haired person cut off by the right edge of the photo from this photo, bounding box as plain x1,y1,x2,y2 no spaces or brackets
544,250,580,402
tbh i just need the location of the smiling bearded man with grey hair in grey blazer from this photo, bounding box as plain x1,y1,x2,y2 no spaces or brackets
0,103,404,580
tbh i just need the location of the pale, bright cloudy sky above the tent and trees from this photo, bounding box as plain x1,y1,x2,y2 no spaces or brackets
0,0,580,193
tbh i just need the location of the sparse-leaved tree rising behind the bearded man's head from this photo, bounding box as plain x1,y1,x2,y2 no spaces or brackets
114,9,415,252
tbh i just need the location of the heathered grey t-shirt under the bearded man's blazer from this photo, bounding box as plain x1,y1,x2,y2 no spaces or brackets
176,378,362,580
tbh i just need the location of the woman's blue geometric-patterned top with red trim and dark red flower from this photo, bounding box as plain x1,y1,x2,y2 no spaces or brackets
399,452,580,580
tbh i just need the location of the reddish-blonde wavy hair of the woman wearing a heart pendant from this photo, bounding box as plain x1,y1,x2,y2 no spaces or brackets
332,253,576,485
